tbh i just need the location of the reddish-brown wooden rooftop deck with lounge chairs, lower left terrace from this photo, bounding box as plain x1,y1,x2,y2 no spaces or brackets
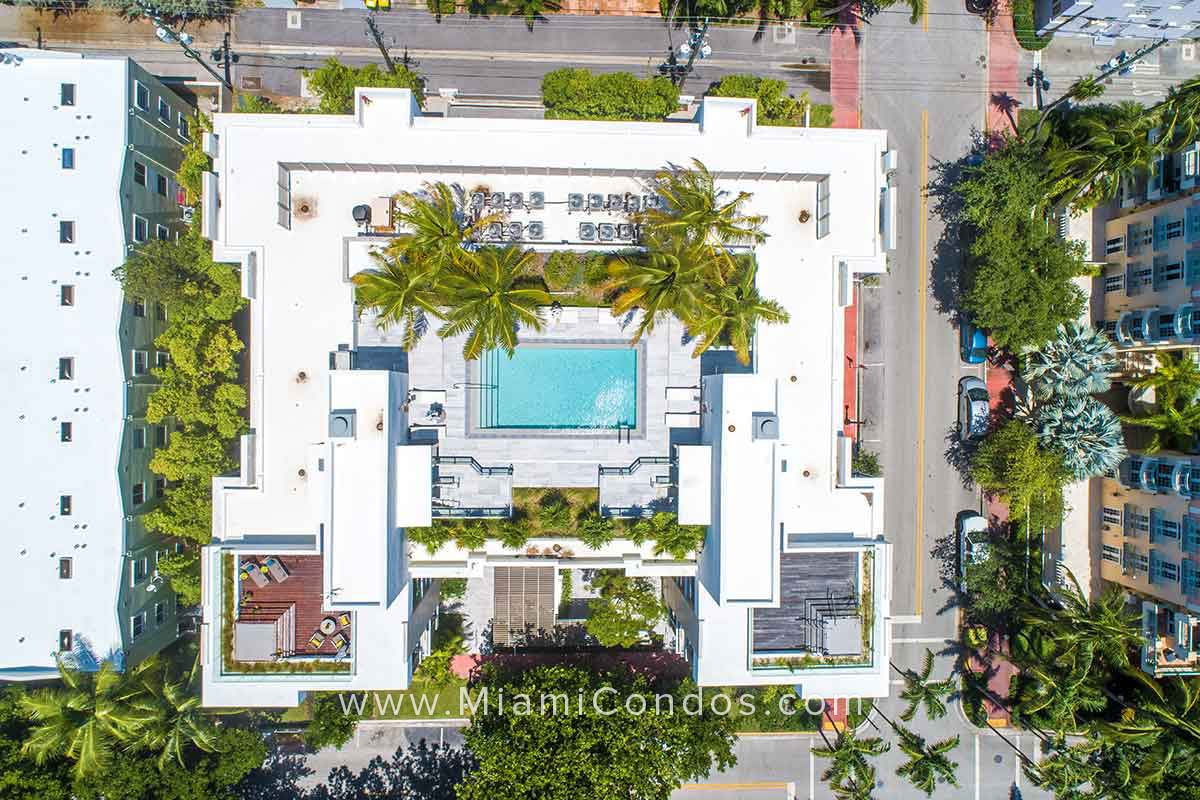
236,555,353,656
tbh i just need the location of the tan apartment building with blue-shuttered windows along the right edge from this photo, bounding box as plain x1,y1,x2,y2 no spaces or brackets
1091,170,1200,675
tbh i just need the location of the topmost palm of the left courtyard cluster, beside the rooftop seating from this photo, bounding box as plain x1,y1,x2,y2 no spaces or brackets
392,181,504,270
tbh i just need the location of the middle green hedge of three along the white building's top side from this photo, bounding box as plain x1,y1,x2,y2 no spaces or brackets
541,67,679,121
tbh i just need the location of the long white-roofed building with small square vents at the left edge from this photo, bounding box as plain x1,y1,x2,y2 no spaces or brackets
0,49,193,680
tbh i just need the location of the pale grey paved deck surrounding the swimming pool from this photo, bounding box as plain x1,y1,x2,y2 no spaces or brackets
358,308,700,487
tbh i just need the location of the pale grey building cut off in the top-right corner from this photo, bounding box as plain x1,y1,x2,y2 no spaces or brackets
1036,0,1200,40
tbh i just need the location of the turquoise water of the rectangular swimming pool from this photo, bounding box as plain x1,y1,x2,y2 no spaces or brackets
478,344,637,429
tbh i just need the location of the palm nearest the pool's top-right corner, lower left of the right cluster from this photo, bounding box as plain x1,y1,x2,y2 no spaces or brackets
608,231,724,342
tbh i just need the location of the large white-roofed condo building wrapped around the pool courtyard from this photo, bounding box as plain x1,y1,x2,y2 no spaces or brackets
202,89,895,706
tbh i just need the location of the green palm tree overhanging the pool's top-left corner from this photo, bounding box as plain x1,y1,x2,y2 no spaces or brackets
438,247,550,361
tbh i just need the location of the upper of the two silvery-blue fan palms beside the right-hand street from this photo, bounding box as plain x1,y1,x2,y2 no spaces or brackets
1021,321,1117,399
